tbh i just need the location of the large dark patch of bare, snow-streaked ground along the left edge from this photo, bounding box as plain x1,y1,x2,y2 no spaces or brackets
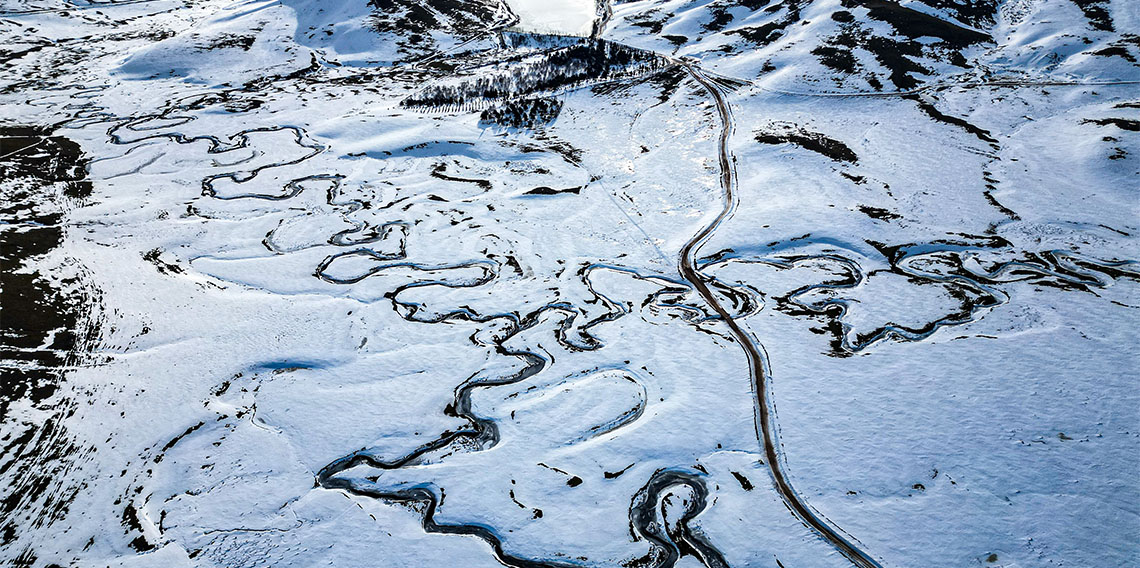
0,125,97,566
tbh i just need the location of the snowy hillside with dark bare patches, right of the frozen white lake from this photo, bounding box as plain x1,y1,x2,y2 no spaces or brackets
608,0,1140,92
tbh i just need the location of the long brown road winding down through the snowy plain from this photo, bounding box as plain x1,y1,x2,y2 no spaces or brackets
677,62,881,568
